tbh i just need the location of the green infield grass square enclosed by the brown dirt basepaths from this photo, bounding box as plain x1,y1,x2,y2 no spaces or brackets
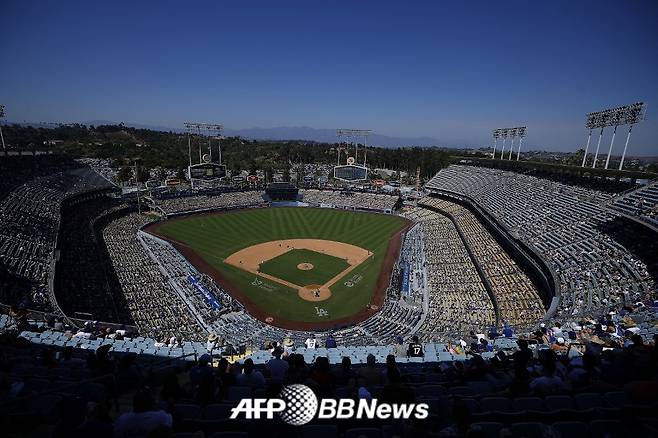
258,249,350,286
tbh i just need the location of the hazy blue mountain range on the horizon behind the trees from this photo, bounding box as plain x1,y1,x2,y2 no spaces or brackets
8,120,448,147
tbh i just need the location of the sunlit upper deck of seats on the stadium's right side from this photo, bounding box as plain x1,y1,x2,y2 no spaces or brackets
427,165,655,317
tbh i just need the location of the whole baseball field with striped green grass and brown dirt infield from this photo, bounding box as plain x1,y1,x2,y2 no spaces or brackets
146,207,407,329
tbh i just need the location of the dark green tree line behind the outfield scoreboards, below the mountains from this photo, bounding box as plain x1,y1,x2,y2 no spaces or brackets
3,124,450,178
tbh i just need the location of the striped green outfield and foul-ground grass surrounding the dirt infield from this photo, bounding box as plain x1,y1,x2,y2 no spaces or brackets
151,207,405,322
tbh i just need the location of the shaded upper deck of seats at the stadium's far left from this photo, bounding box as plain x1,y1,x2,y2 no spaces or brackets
0,156,111,311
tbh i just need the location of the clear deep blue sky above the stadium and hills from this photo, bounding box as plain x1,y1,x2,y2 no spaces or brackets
0,0,658,155
